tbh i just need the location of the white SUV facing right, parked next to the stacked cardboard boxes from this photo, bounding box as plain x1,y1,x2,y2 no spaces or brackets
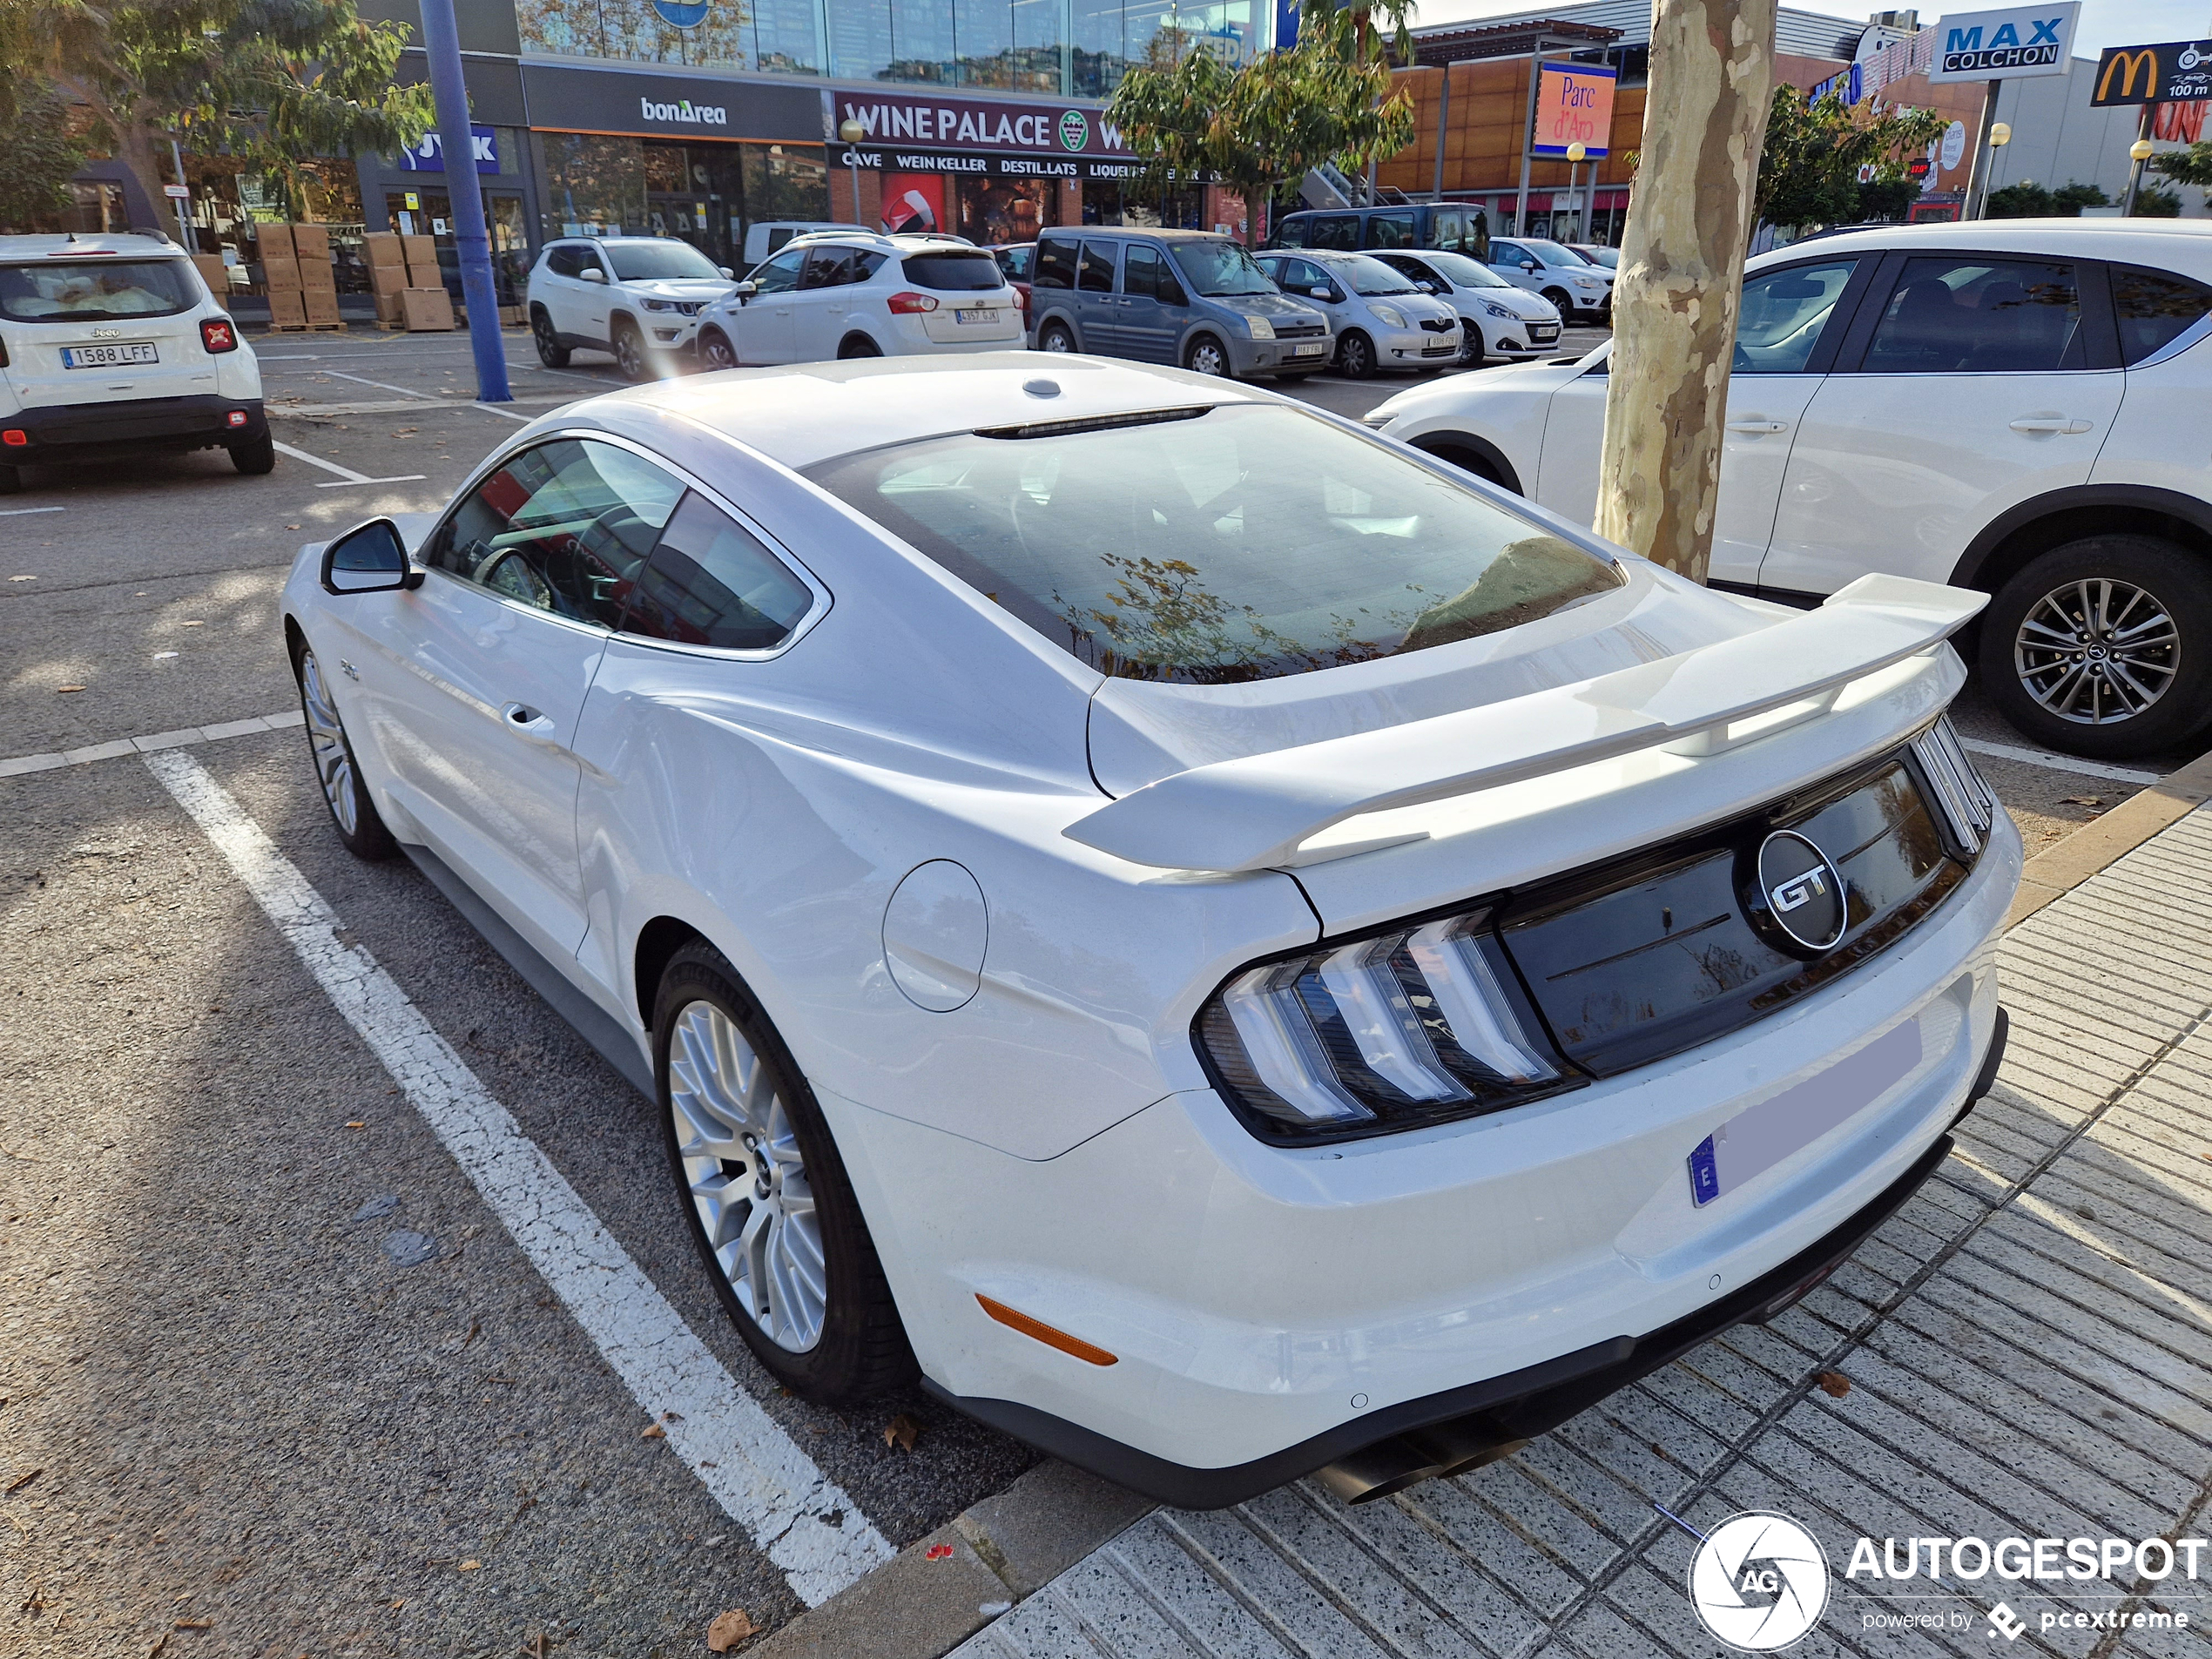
527,237,737,381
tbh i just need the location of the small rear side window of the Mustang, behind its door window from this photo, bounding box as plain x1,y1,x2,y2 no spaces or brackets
622,493,814,651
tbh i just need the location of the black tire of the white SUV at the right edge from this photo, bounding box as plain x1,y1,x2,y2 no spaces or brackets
1979,536,2212,761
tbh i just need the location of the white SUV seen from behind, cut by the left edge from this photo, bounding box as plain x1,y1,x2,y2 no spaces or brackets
0,237,277,496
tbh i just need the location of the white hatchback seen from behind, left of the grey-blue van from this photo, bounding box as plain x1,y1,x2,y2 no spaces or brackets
699,233,1027,369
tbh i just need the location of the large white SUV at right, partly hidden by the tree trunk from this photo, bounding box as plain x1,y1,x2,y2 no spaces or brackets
1367,219,2212,759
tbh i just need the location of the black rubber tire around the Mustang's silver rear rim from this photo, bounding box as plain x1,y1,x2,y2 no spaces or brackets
652,942,921,1402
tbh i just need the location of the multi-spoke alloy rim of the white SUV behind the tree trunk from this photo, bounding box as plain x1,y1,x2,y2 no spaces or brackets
2013,577,2181,725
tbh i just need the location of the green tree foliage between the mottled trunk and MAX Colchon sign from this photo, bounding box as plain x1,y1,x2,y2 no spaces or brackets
1752,86,1949,226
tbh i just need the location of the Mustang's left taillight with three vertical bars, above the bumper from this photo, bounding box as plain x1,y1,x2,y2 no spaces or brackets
1197,911,1581,1139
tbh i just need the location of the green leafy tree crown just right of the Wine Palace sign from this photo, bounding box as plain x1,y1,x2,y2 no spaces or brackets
1106,31,1413,237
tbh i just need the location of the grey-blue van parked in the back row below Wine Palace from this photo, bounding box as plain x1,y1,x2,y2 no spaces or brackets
1028,226,1334,378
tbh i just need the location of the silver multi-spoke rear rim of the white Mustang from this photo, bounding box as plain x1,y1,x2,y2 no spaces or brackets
668,1002,830,1353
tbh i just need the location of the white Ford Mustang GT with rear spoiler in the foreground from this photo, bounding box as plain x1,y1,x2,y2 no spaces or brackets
286,354,2020,1507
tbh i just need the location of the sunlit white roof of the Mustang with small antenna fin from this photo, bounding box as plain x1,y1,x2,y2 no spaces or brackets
583,352,1274,469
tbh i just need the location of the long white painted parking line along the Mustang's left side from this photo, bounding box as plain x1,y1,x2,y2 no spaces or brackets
146,750,896,1608
